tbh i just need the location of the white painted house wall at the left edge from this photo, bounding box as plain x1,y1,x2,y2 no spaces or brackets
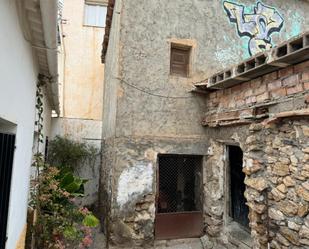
0,0,49,249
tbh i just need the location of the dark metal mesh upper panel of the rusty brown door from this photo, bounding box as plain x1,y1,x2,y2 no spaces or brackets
157,155,202,213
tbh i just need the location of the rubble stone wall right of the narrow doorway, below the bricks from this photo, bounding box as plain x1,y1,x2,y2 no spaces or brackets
244,119,309,249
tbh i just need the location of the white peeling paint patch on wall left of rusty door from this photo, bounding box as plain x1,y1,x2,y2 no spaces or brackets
117,163,154,207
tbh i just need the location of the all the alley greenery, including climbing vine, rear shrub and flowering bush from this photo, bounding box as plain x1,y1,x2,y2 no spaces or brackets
27,76,99,249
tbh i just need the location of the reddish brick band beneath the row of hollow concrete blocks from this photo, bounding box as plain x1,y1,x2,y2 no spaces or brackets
203,61,309,126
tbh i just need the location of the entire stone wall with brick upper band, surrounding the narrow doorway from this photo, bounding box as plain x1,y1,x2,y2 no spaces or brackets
203,61,309,249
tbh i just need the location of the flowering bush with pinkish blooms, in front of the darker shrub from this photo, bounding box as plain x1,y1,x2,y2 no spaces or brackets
35,167,99,249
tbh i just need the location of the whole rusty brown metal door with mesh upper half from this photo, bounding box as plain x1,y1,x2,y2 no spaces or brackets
155,154,204,240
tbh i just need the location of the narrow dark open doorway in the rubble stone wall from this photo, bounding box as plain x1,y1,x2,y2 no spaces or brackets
227,145,249,229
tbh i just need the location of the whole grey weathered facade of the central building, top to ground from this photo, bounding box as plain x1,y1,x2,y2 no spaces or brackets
100,0,309,248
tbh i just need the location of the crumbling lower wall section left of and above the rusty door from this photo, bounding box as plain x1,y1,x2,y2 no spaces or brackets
106,137,207,248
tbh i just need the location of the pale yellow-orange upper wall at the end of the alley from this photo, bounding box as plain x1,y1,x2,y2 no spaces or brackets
61,0,104,120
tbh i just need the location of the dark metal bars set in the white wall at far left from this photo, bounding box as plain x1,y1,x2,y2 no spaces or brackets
0,133,15,249
